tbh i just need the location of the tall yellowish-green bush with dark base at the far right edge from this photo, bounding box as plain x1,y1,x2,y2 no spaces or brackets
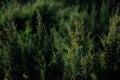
100,13,120,80
